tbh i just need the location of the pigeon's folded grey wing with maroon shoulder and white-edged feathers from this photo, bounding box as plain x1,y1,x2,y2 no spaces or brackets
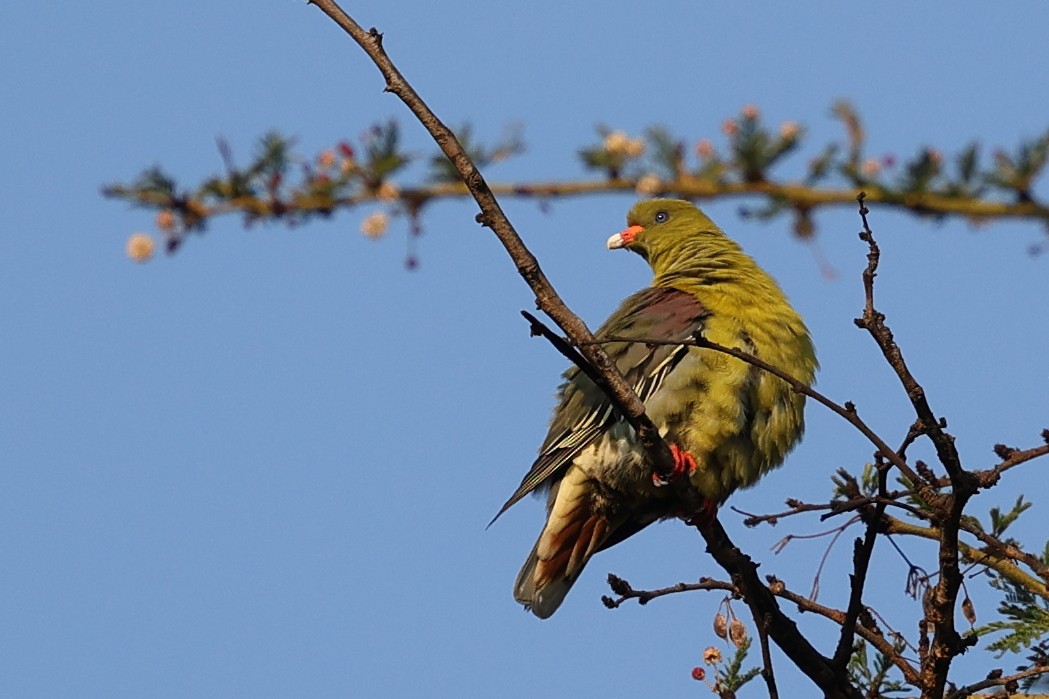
492,287,708,522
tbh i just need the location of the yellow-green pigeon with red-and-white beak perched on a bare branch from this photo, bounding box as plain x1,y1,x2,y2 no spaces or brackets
492,198,818,619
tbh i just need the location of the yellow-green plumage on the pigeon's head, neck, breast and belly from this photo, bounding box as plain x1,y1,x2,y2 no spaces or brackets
627,199,817,502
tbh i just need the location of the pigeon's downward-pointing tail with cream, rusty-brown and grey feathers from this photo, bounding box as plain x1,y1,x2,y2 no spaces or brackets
514,467,616,619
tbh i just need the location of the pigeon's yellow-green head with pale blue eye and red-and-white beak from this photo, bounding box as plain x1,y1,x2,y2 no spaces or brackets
608,199,738,276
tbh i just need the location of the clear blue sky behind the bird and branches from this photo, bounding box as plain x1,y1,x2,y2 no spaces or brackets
0,0,1049,697
